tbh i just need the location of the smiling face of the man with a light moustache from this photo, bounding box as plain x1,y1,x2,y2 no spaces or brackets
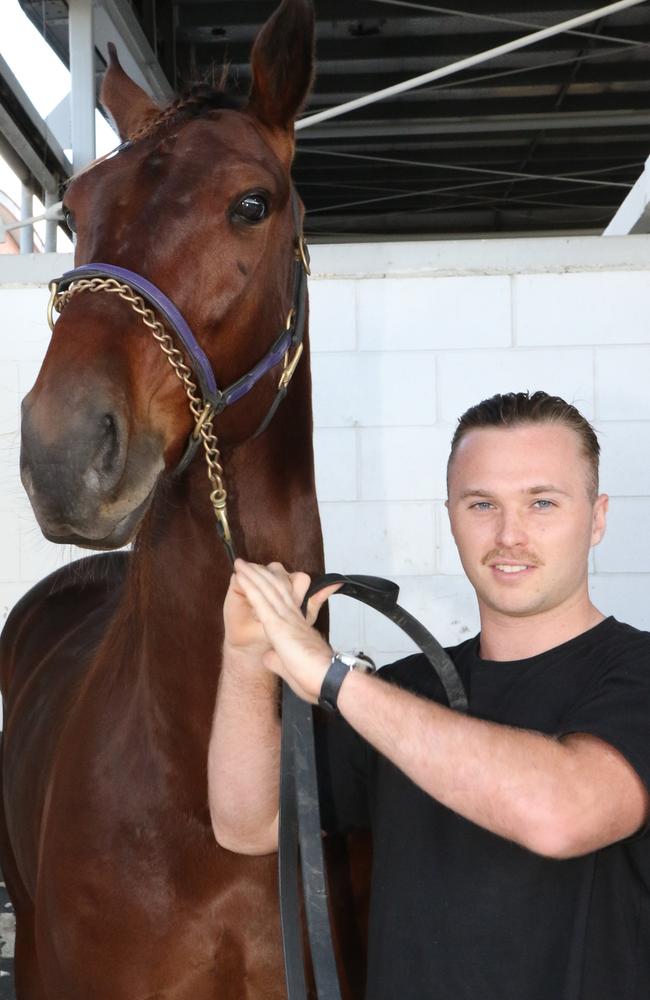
447,424,608,617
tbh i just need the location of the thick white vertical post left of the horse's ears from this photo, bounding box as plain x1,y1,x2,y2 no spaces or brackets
68,0,95,173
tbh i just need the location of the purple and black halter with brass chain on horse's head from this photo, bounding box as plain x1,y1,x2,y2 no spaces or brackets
48,189,310,562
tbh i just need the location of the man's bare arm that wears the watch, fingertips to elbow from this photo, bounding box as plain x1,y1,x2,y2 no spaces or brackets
233,564,648,858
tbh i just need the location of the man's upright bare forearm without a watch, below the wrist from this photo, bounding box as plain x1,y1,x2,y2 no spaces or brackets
208,645,280,854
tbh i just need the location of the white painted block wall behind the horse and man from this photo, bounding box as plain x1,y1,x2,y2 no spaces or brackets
0,236,650,661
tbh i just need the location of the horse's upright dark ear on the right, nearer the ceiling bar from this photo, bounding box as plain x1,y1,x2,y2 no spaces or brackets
250,0,314,130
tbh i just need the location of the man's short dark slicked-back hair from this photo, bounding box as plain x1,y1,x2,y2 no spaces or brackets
447,390,600,499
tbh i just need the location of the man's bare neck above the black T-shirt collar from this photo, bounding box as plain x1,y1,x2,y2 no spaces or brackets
480,598,605,661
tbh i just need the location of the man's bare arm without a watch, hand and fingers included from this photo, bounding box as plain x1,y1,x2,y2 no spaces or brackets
208,560,337,854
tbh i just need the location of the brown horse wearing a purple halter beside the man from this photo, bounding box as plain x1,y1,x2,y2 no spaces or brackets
1,0,354,1000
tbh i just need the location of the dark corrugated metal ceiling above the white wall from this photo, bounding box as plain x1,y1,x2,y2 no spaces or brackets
16,0,650,238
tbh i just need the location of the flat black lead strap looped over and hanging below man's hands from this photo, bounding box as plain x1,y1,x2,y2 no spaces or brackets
278,573,467,1000
